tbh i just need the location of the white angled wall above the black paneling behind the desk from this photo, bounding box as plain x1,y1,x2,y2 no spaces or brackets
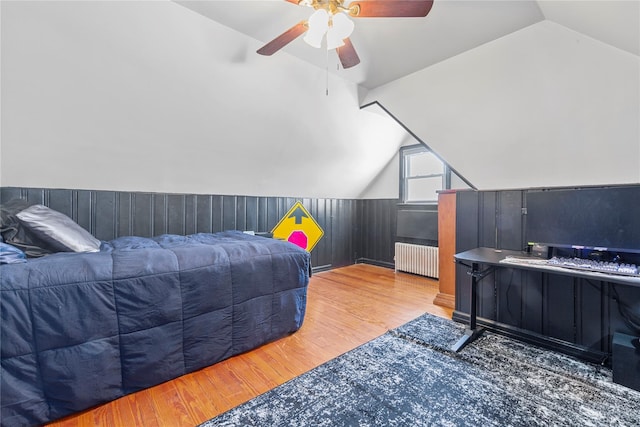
364,21,640,189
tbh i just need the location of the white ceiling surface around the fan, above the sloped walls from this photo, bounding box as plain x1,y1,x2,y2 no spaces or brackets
176,0,640,89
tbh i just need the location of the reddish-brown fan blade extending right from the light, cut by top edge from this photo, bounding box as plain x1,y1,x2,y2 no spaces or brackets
349,0,433,18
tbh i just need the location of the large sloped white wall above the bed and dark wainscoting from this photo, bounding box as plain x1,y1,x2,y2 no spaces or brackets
0,1,406,198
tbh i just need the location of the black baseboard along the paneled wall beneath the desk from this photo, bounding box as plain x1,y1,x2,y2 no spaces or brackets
451,310,611,366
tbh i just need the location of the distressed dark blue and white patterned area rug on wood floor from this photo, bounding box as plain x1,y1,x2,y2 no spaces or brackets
202,314,640,427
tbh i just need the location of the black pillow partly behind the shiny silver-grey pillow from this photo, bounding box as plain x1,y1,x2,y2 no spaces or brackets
0,199,51,258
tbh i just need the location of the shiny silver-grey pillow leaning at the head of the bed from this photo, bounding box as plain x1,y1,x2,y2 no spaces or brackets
16,205,100,252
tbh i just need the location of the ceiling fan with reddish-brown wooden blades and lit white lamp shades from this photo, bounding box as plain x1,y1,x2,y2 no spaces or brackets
257,0,433,69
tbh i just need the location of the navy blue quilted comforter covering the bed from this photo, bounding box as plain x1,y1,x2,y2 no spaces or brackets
0,232,310,426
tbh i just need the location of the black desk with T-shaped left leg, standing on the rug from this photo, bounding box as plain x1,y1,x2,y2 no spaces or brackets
452,248,640,351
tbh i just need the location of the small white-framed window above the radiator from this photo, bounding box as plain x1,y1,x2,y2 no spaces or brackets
400,145,450,203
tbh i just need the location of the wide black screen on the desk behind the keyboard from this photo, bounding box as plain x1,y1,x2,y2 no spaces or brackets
526,186,640,253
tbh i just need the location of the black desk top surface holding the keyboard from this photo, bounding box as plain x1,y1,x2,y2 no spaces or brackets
454,248,640,287
